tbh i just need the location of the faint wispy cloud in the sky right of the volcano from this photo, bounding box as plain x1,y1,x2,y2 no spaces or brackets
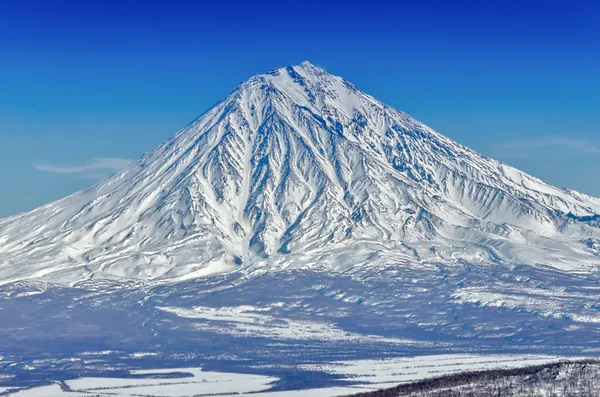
500,136,600,156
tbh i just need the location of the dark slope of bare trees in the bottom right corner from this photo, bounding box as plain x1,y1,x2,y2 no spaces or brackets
352,360,600,397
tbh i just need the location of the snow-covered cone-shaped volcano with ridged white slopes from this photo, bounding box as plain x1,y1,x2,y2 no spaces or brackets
0,62,600,283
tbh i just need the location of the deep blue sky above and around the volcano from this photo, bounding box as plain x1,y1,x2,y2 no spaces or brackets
0,0,600,216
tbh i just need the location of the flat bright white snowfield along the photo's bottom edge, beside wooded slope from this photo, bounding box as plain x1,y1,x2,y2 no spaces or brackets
4,354,559,397
